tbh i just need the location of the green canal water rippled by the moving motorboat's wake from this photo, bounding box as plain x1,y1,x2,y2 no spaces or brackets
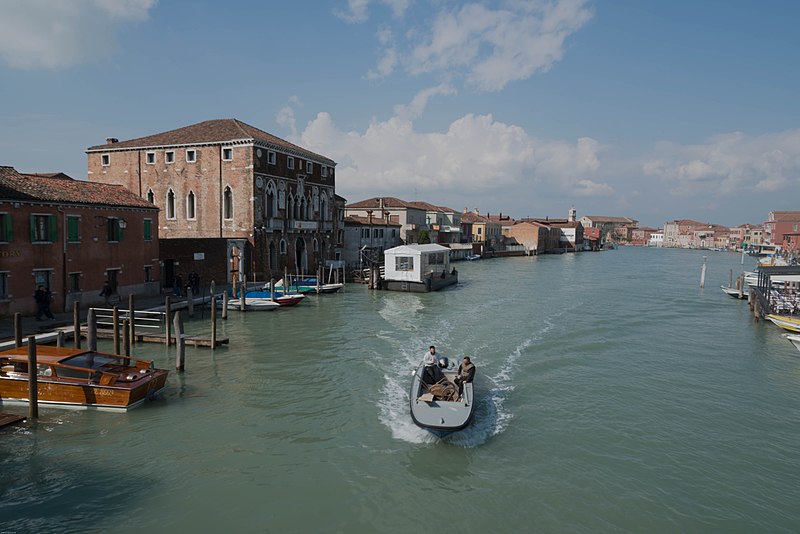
0,248,800,533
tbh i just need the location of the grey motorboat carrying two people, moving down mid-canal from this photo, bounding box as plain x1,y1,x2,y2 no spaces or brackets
409,362,475,437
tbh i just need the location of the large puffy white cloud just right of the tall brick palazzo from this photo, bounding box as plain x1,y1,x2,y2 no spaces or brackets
297,85,613,204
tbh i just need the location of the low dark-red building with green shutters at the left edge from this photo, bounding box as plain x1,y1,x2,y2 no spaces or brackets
0,167,160,316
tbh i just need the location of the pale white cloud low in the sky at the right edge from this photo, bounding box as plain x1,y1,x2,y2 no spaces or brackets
642,130,800,196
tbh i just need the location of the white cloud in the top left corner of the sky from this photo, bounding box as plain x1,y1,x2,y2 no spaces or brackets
0,0,156,70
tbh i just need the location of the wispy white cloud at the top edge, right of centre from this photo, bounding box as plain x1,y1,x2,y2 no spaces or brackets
368,0,592,92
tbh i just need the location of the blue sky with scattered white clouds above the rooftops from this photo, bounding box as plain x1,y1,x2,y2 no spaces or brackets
0,0,800,227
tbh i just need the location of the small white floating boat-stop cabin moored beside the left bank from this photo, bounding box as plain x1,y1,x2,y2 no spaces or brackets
382,244,458,293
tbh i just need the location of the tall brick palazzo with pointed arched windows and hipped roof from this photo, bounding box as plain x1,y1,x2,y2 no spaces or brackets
86,119,343,292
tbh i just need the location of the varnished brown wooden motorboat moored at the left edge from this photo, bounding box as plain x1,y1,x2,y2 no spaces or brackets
0,345,169,411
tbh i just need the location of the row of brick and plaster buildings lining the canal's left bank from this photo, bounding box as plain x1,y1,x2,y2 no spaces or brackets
0,119,635,316
